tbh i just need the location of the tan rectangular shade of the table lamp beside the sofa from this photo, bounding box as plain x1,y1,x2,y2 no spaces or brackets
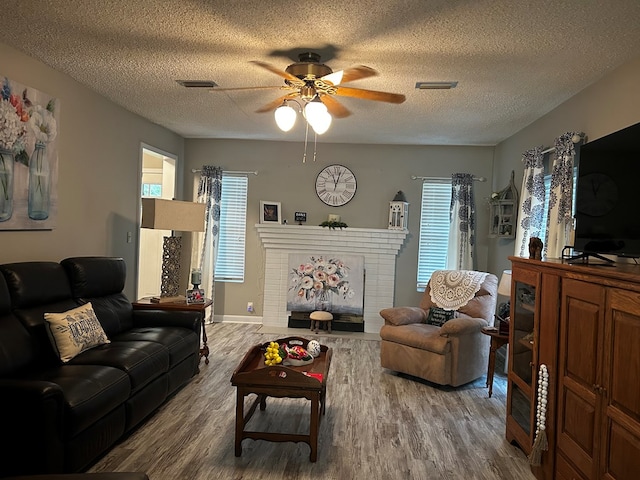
141,198,205,232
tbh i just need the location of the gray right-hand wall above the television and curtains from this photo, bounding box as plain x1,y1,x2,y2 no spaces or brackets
489,58,640,278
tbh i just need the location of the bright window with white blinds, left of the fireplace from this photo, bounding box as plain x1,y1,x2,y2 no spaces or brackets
215,173,249,283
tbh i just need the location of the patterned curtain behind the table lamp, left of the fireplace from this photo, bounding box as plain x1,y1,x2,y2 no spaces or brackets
192,165,222,323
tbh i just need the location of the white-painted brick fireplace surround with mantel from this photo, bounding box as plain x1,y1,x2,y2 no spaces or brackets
256,224,408,333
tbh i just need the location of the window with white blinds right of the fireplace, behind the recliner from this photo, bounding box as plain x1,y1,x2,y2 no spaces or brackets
417,180,451,292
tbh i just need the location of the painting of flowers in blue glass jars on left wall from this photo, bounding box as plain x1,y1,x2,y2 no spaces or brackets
0,77,59,230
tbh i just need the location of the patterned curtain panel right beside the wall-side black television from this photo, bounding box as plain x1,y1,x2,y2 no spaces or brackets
544,132,576,258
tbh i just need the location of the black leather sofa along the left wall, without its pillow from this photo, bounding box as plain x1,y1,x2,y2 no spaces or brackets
0,257,201,477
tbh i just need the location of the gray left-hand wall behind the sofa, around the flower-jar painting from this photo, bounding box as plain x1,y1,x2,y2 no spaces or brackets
0,44,184,298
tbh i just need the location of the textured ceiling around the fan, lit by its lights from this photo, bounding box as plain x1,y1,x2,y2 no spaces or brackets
0,0,640,145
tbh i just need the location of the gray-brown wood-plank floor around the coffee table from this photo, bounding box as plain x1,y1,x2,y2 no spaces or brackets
89,324,534,480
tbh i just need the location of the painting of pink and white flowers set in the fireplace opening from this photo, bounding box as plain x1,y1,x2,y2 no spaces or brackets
287,253,364,315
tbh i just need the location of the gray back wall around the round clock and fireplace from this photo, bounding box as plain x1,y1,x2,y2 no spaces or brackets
185,140,493,315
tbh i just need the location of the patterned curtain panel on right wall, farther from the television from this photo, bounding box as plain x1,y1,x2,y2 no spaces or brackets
514,147,544,257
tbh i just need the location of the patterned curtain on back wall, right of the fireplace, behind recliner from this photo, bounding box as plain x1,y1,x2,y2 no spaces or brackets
447,173,476,270
